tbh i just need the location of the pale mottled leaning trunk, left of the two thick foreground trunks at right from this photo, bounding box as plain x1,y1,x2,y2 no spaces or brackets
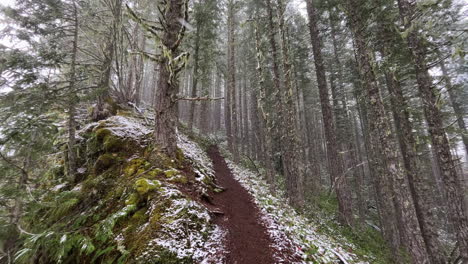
347,0,428,263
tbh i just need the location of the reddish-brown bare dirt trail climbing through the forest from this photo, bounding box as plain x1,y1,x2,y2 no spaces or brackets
208,146,301,264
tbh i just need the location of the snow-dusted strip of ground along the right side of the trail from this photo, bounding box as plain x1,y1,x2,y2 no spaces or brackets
226,160,365,263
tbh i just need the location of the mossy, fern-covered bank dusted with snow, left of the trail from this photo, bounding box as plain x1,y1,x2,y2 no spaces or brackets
16,113,224,264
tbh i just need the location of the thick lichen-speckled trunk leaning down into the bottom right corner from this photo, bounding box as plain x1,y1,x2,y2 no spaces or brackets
398,0,468,262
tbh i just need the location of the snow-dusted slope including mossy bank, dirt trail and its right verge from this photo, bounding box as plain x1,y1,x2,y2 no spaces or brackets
16,113,372,264
